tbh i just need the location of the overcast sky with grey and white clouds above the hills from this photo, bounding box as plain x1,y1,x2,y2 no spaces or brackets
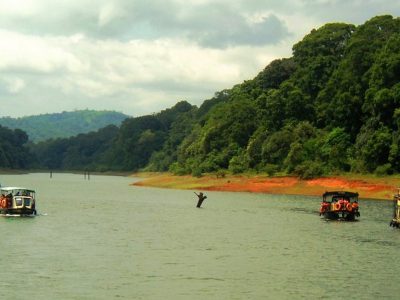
0,0,400,117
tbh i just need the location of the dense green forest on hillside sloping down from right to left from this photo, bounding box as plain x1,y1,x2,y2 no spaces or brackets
0,16,400,178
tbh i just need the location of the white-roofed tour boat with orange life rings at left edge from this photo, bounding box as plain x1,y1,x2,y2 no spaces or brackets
0,187,36,216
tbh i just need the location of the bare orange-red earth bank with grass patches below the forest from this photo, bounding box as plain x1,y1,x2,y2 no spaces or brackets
131,172,400,200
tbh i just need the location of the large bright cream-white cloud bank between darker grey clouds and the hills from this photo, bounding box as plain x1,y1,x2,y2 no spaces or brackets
0,31,282,115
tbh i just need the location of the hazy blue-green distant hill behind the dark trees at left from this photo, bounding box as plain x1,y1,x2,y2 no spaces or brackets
0,109,129,142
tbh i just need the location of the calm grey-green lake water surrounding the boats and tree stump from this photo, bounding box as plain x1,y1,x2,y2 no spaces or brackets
0,173,400,299
